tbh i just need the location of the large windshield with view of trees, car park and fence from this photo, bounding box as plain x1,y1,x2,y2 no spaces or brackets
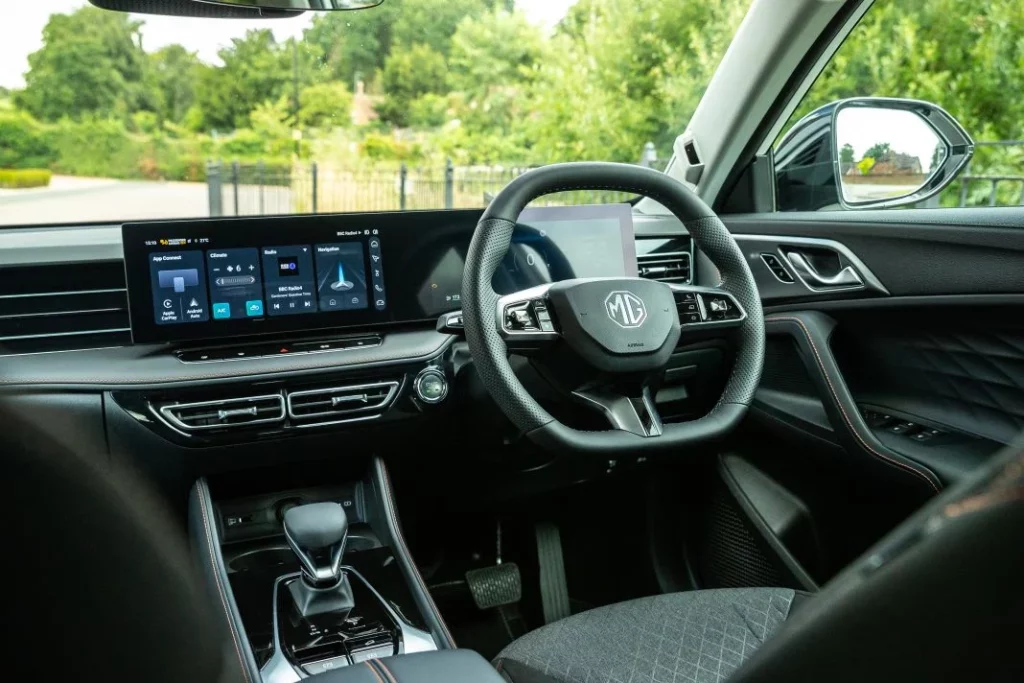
0,0,749,225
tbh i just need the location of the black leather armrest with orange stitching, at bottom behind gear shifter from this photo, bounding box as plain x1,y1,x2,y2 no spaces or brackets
313,650,504,683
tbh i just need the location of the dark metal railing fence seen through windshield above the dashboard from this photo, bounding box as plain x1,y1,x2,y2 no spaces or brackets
207,150,665,216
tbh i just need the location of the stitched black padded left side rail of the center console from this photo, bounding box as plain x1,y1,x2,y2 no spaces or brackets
188,479,260,683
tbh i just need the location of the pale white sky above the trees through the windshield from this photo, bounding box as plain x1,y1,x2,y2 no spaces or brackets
0,0,575,88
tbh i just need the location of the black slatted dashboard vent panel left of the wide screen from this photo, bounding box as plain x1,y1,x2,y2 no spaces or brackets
0,261,131,355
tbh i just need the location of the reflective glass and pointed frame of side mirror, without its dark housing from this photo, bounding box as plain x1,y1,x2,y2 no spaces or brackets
831,97,974,209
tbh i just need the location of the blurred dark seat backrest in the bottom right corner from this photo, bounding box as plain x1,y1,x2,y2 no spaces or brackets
729,449,1024,683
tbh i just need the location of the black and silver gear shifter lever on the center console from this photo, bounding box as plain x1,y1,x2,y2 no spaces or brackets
285,503,354,616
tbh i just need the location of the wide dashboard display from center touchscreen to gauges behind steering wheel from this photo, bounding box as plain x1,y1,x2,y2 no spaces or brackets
122,205,636,342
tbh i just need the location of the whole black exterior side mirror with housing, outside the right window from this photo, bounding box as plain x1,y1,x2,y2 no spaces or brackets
774,97,974,211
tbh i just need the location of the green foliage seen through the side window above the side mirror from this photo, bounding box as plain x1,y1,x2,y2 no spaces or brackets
792,0,1024,139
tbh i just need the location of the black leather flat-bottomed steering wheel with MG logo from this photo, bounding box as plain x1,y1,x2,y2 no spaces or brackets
462,163,765,454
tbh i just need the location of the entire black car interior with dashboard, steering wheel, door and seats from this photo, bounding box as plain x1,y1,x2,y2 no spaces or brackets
0,0,1024,683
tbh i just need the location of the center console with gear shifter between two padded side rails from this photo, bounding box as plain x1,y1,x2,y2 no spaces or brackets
189,459,455,683
